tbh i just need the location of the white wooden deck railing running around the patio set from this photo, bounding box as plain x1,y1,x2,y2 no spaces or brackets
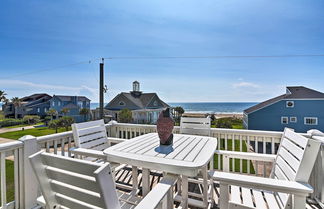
0,123,324,209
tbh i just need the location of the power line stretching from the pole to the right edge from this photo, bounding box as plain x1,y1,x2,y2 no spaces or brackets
104,54,324,60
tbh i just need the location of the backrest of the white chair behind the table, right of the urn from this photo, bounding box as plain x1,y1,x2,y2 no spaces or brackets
180,117,210,136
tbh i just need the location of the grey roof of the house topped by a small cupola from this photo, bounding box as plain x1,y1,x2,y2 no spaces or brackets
106,92,169,109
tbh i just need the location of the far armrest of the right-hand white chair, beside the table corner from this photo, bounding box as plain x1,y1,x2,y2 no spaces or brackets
215,150,277,162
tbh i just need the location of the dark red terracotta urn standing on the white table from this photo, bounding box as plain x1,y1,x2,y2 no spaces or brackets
156,108,174,146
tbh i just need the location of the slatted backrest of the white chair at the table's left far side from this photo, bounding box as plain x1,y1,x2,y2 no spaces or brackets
72,120,109,150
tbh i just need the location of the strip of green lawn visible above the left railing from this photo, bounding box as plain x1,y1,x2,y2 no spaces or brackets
0,127,70,139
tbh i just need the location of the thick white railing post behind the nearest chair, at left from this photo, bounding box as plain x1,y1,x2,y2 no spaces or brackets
19,135,40,209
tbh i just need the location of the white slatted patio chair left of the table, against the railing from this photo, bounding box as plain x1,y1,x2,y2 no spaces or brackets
71,120,138,192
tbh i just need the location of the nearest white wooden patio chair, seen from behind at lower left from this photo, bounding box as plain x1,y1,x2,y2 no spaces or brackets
29,151,176,209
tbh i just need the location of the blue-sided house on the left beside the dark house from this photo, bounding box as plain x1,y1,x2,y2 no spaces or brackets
50,95,90,123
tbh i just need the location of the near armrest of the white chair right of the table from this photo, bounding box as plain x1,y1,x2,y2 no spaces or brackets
209,171,313,196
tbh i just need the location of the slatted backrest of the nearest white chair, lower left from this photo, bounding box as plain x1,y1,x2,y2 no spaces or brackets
29,152,120,209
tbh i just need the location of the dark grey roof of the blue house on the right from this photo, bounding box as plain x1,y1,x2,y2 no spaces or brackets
244,86,324,114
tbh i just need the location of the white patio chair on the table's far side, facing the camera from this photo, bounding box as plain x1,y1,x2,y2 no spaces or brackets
178,117,216,205
